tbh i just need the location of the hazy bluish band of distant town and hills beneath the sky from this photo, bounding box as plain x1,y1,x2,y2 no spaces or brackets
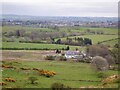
0,15,118,28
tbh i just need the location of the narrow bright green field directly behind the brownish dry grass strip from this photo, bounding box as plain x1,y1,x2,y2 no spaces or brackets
2,42,84,50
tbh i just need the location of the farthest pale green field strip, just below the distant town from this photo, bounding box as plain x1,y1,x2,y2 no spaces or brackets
2,26,118,34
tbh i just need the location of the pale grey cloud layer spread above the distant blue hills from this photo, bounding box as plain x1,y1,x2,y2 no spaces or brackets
2,2,117,16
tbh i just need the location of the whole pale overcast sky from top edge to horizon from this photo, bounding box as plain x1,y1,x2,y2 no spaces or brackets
0,0,119,17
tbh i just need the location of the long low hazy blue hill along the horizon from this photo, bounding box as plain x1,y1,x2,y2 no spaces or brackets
2,14,118,22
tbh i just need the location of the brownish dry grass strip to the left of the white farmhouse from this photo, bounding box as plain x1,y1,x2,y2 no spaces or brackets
2,50,56,61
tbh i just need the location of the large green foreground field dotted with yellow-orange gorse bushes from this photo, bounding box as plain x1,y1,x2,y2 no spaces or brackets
2,61,118,88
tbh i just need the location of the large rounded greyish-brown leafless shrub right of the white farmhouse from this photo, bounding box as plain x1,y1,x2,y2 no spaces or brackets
91,56,108,71
